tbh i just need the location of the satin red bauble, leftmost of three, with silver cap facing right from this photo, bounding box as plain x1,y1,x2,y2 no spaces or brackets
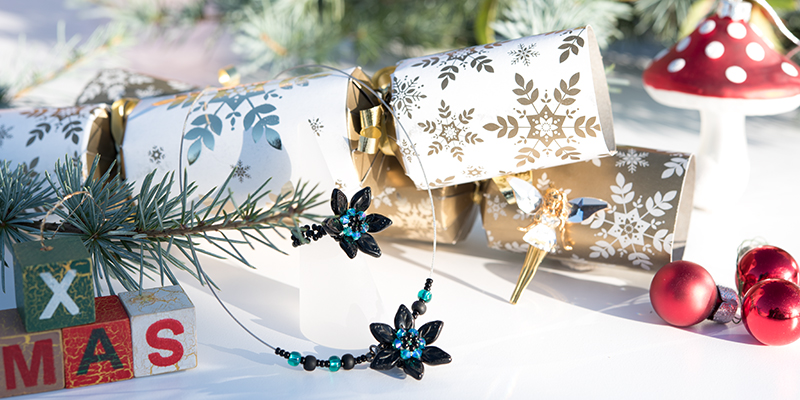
650,261,718,326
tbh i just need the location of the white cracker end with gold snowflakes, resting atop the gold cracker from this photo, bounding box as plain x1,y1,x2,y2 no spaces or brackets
392,27,615,189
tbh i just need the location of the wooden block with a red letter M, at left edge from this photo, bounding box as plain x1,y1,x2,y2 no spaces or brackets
0,309,64,397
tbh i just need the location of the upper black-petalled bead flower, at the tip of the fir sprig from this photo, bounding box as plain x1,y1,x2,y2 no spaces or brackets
322,187,392,258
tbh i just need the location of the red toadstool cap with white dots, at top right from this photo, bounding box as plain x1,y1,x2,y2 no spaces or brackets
642,3,800,115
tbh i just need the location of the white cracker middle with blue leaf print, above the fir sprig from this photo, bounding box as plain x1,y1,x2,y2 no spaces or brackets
115,69,361,205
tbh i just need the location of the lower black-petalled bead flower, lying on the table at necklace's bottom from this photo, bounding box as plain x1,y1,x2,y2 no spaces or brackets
369,305,452,380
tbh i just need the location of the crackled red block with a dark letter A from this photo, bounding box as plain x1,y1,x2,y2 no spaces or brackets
62,296,133,388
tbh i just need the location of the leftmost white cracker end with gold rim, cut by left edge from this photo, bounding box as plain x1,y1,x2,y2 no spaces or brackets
0,104,116,176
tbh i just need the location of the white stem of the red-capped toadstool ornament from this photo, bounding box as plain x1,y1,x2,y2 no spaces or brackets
694,107,750,210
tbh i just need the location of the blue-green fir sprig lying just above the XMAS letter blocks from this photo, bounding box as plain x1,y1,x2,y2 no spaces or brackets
0,160,322,295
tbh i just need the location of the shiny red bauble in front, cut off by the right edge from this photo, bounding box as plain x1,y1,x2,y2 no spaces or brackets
742,279,800,346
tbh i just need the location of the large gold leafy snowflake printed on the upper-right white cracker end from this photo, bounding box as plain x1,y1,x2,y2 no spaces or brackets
483,73,600,168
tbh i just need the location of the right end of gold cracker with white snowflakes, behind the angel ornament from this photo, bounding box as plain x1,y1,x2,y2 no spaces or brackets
481,146,694,270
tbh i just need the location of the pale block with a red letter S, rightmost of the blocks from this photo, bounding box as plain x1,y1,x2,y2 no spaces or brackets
119,286,197,378
